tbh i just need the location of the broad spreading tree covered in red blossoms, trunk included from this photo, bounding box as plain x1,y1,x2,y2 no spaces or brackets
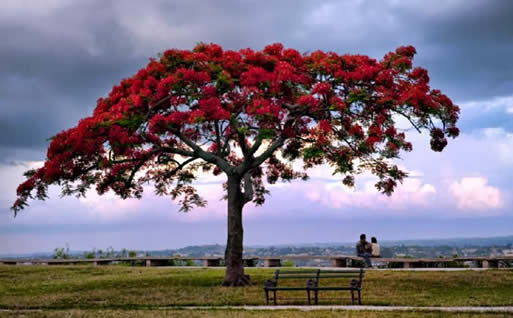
12,44,459,286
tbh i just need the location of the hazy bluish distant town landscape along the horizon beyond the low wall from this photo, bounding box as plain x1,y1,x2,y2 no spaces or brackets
1,236,513,266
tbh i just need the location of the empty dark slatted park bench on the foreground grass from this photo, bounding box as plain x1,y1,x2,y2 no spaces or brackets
264,268,364,305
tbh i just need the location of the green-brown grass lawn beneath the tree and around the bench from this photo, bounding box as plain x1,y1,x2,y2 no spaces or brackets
0,266,513,317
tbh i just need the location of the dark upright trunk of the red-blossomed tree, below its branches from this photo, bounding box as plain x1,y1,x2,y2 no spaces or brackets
223,176,249,286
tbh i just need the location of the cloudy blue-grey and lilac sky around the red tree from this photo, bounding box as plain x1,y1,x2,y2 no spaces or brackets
0,0,513,254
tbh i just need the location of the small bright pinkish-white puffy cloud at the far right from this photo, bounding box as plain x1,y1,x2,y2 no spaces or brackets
449,177,503,210
